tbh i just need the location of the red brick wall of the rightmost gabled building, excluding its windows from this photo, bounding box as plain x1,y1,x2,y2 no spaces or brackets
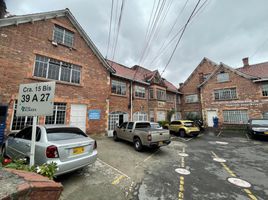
201,65,268,124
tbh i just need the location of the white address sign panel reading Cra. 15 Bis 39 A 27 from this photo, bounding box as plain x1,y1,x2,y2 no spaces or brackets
16,82,55,116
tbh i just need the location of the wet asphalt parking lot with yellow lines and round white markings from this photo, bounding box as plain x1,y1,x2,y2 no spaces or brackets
57,132,268,200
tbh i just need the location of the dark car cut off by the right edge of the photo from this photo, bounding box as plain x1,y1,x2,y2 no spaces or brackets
247,119,268,138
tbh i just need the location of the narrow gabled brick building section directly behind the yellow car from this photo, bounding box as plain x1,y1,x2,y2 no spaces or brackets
179,58,217,119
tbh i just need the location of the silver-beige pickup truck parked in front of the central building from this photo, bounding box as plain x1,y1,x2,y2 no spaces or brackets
113,121,170,151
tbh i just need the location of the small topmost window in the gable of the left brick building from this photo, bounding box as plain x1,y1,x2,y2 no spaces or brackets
53,26,74,47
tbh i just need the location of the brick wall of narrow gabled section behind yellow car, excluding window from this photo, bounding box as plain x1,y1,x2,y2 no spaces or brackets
180,59,216,119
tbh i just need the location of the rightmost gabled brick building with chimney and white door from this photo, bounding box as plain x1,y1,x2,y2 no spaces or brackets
199,58,268,127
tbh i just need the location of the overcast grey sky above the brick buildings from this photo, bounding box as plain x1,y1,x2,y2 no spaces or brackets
5,0,268,86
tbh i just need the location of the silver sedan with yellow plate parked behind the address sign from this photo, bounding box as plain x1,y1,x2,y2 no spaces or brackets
2,125,97,176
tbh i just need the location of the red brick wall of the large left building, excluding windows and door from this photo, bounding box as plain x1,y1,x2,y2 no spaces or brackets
0,17,110,133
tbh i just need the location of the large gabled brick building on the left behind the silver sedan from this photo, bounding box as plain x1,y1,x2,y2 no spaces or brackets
0,9,115,133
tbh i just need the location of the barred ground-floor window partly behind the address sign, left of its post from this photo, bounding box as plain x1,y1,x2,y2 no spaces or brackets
11,101,33,131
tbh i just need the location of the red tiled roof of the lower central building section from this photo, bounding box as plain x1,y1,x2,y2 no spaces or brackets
107,60,178,92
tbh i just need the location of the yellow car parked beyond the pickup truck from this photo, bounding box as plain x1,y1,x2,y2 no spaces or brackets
168,120,200,137
